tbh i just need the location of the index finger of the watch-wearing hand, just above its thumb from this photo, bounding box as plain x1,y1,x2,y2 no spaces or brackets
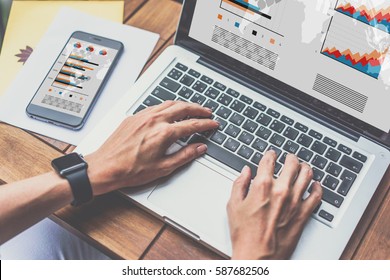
170,119,219,141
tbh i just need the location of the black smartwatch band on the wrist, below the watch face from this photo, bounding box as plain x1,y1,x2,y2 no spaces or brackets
64,166,93,206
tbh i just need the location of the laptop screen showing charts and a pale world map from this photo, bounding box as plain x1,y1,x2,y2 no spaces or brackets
189,0,390,132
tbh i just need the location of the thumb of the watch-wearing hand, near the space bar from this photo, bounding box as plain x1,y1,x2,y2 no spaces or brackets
160,143,207,176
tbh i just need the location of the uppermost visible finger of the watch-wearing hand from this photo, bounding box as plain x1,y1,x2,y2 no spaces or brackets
161,101,212,123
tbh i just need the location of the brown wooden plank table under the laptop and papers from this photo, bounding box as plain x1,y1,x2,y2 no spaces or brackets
0,0,390,259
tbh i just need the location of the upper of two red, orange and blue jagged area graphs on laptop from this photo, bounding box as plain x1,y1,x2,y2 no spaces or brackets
336,0,390,33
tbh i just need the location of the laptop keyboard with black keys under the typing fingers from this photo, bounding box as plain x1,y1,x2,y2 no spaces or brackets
134,63,367,224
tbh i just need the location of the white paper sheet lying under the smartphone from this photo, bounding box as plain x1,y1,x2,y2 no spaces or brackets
0,8,159,145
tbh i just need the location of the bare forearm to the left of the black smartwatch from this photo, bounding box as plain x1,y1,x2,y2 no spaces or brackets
0,172,73,244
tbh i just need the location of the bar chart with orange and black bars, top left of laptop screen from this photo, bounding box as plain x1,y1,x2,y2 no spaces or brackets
220,0,288,37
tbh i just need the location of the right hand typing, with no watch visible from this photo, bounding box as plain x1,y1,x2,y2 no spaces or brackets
227,151,322,259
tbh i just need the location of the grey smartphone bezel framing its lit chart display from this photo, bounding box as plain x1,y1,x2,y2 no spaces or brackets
26,31,124,130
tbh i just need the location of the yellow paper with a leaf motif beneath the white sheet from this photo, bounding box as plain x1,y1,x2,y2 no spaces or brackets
0,0,124,96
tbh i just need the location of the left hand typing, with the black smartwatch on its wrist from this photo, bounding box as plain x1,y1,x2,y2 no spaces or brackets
86,101,219,195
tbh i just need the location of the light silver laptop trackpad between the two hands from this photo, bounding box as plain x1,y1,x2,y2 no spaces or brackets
148,161,233,253
